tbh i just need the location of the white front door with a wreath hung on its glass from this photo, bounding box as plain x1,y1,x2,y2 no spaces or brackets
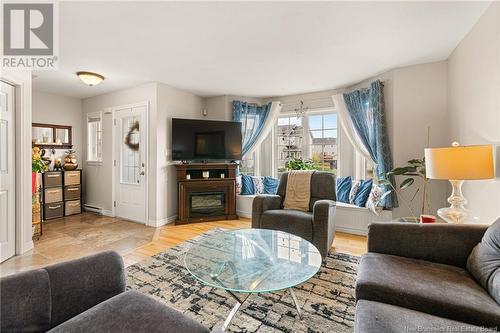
114,105,148,223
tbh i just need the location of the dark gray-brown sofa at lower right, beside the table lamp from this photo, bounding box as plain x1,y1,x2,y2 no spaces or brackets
355,219,500,333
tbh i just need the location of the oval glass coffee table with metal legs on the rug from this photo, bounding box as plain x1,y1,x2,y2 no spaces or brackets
184,229,322,331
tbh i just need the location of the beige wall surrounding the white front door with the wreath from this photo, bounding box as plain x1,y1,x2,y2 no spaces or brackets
83,83,206,226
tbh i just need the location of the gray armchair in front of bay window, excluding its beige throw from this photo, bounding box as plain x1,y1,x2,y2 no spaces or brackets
252,171,337,258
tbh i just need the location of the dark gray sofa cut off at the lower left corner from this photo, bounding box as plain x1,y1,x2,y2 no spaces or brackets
0,251,209,333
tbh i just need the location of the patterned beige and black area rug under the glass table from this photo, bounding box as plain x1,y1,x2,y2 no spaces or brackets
127,229,359,333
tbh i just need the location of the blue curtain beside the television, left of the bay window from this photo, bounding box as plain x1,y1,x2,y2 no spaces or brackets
233,101,271,155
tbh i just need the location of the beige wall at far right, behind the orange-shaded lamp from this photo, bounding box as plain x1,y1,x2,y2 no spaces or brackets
448,2,500,223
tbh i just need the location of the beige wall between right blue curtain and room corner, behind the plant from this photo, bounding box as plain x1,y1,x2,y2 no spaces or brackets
391,61,450,216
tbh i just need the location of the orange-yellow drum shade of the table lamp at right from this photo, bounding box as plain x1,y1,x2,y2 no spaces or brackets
425,145,494,180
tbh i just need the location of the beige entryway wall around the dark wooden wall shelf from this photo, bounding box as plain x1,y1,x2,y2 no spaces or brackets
32,91,85,162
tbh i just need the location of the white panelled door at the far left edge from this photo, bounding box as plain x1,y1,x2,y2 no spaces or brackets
0,81,16,262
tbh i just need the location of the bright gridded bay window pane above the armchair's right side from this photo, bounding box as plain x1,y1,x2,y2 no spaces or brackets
308,113,338,173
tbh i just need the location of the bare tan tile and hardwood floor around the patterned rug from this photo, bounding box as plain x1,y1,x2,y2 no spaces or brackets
0,213,366,276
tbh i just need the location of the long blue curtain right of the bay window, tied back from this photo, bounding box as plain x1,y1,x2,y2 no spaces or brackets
344,80,398,208
